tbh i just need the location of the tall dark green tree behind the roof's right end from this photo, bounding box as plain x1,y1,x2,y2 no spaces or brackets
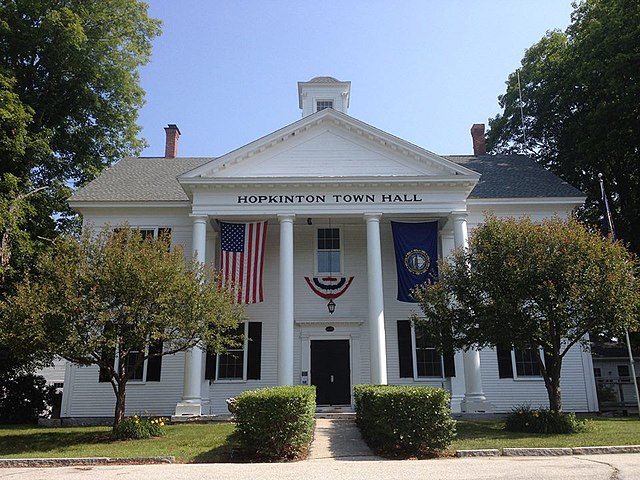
487,0,640,253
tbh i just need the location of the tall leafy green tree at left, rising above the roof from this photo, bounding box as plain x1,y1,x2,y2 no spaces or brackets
0,0,160,373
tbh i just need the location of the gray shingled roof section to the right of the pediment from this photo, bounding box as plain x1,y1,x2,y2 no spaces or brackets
444,155,585,198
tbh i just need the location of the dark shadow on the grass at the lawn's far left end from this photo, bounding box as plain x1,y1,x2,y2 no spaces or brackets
0,429,116,455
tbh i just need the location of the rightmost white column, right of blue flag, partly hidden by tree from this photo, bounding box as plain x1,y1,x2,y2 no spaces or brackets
451,212,491,413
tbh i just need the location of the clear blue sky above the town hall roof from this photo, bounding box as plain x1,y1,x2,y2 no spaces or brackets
139,0,572,156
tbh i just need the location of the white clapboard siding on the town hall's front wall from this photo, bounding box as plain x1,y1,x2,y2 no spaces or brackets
63,209,593,417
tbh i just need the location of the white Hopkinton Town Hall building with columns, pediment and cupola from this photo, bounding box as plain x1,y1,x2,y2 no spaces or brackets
62,77,597,417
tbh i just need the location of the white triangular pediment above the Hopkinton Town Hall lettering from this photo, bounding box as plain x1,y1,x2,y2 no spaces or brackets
181,109,478,181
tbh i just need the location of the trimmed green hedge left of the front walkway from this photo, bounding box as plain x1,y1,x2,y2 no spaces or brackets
229,386,316,460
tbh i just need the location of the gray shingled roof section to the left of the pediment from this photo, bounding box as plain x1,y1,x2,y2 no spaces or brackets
69,157,215,202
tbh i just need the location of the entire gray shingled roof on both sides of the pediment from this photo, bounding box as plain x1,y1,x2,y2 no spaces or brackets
70,155,584,202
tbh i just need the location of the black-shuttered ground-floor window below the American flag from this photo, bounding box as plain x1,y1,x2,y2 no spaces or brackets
205,322,262,381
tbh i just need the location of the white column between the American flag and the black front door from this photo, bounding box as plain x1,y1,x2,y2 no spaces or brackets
278,214,295,385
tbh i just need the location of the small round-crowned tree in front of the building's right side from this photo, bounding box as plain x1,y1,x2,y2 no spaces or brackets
414,216,640,411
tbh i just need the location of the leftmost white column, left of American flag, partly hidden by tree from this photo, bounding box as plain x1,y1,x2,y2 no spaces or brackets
175,215,208,416
